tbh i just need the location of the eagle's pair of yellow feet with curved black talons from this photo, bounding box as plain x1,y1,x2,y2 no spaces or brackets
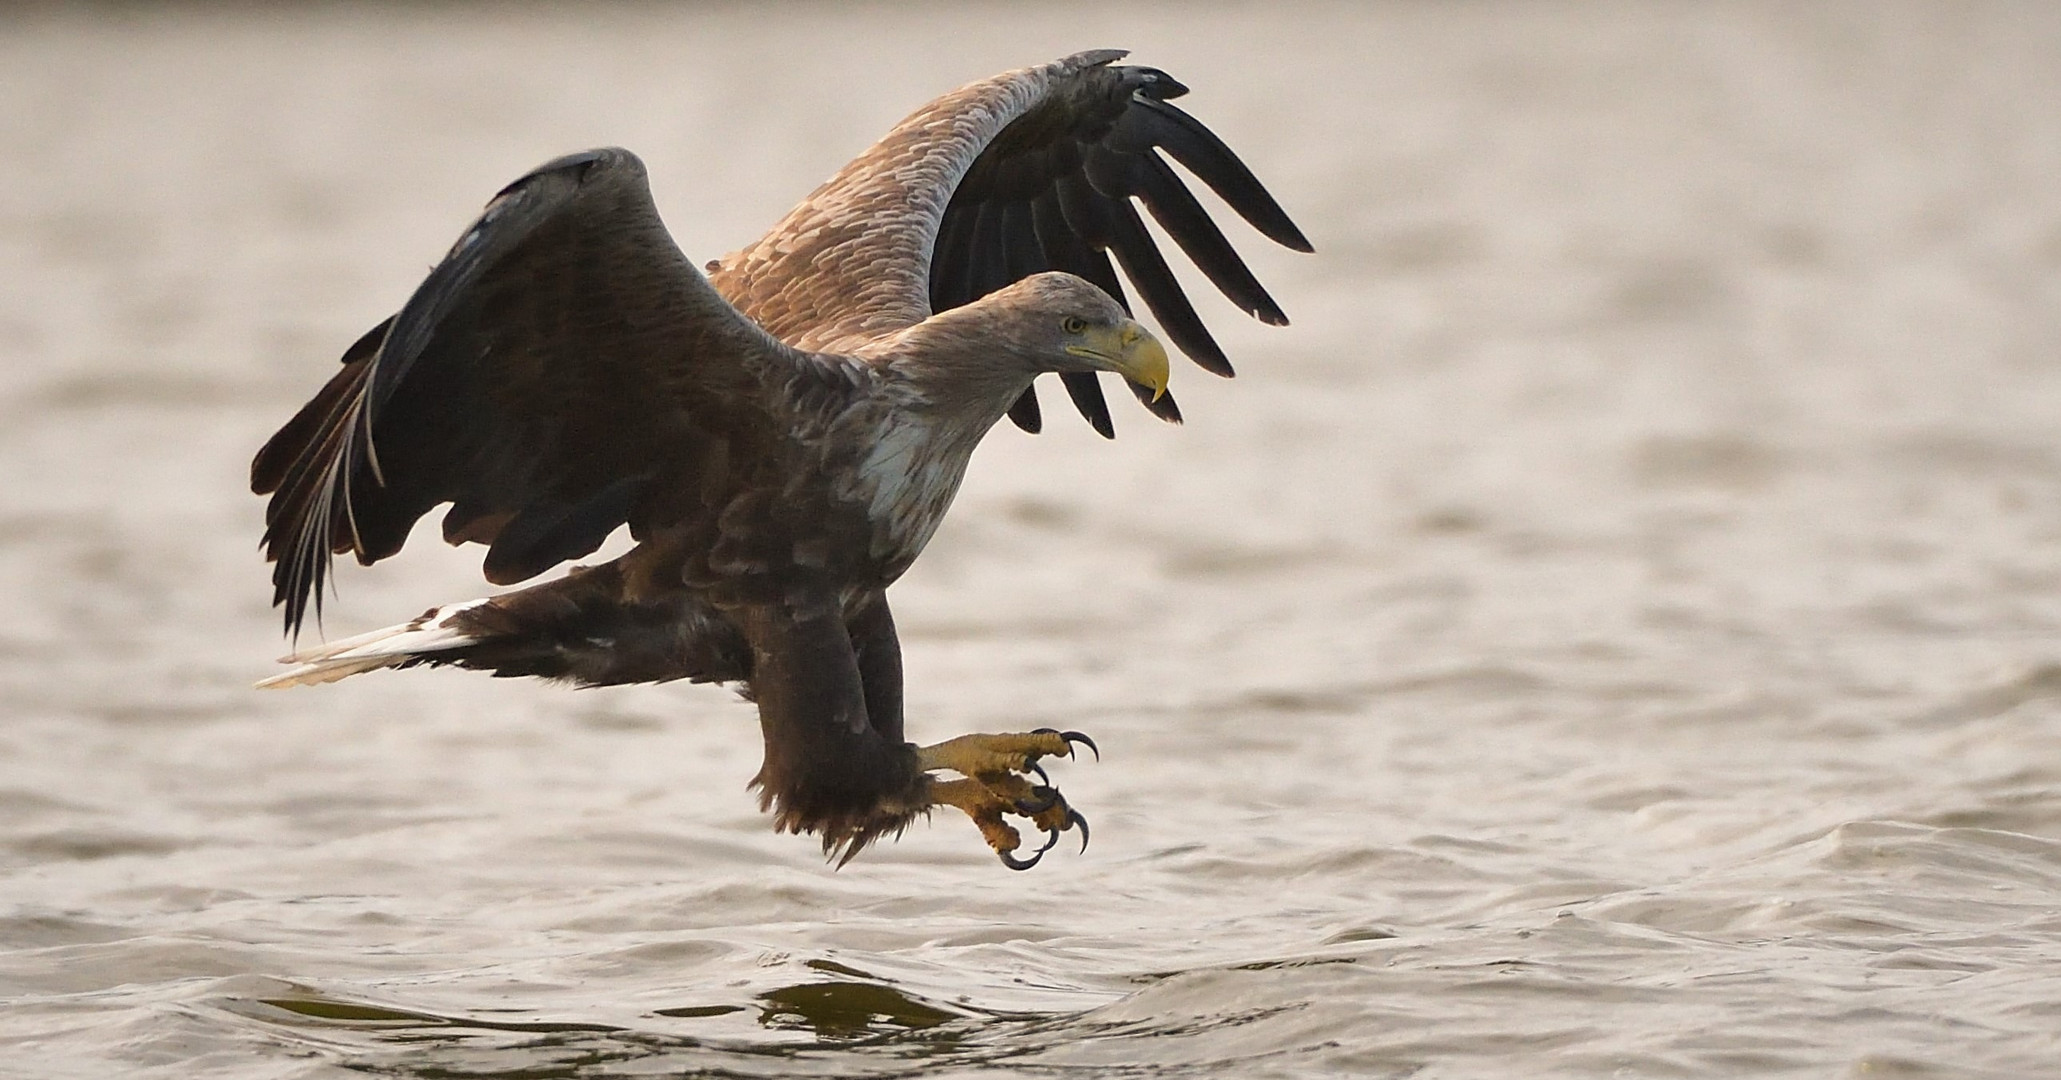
917,728,1101,870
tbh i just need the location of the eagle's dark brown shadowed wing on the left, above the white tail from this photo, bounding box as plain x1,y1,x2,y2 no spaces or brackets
251,148,853,631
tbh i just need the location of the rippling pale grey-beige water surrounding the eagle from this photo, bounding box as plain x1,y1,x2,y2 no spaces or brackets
0,2,2061,1078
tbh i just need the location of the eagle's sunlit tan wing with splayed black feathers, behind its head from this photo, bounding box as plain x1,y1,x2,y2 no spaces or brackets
713,49,1311,435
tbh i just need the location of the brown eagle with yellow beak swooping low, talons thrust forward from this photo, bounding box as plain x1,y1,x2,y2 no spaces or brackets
251,49,1311,870
